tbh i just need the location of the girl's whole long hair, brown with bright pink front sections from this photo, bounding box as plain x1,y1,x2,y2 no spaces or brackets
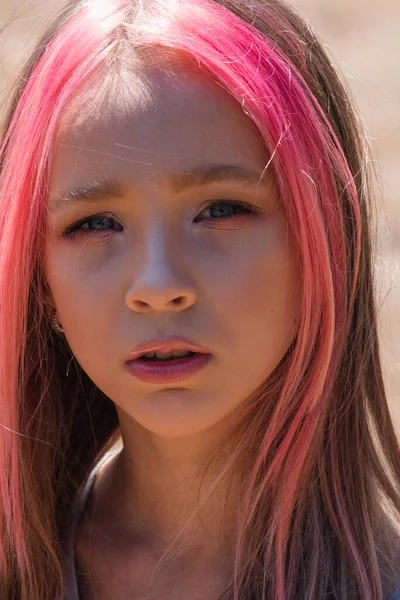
0,0,400,600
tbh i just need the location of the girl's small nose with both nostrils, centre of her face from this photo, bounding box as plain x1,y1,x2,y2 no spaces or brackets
126,236,197,313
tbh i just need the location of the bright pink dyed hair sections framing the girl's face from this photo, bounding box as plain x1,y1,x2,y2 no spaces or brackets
0,0,399,600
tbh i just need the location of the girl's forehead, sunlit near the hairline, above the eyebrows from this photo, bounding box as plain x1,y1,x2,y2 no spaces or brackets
54,67,267,188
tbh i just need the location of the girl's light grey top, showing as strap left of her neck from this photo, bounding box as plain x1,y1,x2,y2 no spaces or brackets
64,446,400,600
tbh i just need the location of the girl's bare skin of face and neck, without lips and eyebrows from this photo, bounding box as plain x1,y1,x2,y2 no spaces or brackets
45,66,301,598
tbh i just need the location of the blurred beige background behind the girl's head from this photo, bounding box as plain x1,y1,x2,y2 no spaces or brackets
0,0,400,426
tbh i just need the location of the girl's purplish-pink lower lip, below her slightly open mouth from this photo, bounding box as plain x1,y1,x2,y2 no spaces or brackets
125,354,213,383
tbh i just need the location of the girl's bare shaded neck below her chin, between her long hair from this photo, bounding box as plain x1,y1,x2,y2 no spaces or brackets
90,420,238,565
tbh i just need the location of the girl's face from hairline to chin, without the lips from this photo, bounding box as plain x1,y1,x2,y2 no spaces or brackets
45,67,301,437
